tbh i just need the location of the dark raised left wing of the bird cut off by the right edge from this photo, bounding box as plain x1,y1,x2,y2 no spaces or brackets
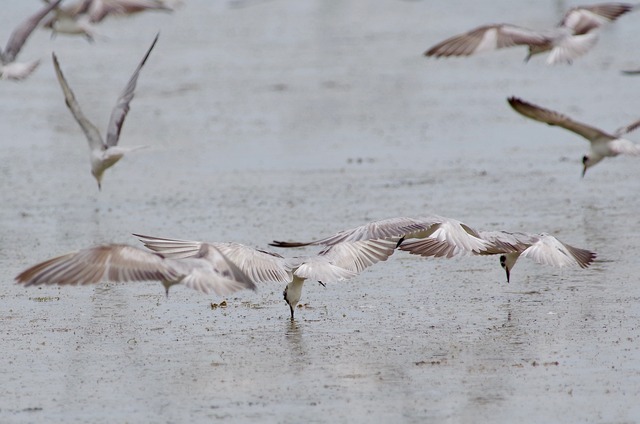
507,97,616,141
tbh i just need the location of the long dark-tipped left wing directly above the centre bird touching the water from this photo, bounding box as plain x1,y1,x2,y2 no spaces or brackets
269,217,424,247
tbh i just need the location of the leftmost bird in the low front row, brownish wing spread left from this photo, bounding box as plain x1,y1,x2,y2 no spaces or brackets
16,244,256,296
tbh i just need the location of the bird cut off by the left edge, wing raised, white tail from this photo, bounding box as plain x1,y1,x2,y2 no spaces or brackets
0,0,62,80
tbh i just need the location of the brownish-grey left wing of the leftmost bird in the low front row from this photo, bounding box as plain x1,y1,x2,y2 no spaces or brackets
16,244,180,286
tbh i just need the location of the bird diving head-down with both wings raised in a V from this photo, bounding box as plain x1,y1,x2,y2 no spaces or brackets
52,34,159,189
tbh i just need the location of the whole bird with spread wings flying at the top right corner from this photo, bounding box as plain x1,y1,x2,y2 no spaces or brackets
424,3,634,64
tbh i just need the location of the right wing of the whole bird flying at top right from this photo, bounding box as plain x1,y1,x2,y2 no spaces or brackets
560,3,634,35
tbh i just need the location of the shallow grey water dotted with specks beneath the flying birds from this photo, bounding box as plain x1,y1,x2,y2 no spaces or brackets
0,0,640,423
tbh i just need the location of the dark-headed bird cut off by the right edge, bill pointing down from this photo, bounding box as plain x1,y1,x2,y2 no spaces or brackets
507,97,640,177
